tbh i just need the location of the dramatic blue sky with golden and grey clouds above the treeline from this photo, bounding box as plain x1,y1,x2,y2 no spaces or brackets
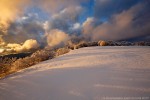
0,0,150,44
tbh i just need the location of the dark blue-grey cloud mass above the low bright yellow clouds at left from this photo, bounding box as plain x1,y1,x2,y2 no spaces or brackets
3,13,44,43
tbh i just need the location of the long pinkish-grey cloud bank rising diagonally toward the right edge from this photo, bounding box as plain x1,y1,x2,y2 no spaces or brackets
83,3,150,40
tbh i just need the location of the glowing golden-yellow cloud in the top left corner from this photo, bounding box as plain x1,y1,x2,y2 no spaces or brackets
0,0,29,27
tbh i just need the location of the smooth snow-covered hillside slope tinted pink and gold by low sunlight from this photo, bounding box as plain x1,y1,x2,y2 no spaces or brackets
0,46,150,100
